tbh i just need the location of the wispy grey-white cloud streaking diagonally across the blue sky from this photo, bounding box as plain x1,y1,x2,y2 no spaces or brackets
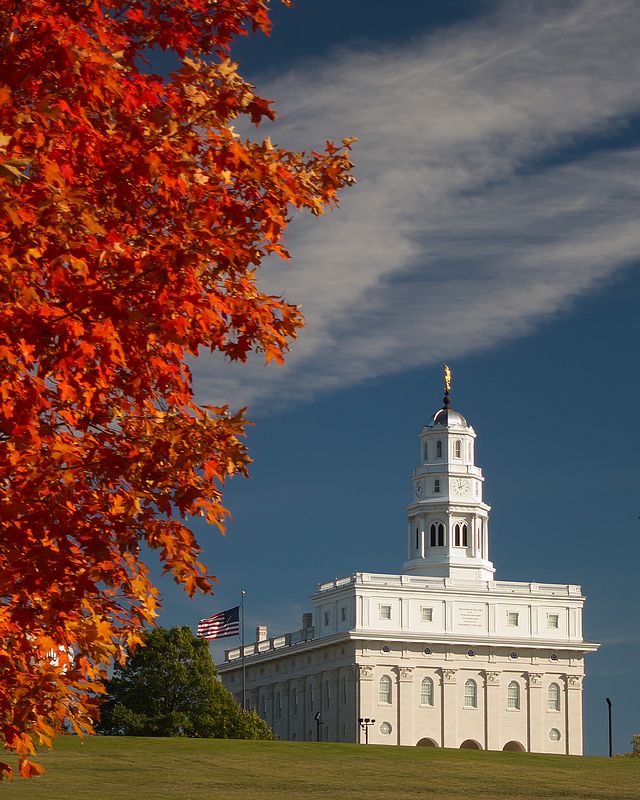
195,0,640,408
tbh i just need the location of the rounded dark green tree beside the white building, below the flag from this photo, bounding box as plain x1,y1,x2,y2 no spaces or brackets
98,626,275,739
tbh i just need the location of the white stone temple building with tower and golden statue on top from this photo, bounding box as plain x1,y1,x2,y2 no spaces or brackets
218,368,598,755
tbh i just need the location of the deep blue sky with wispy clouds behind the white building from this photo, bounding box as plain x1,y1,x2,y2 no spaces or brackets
152,0,640,755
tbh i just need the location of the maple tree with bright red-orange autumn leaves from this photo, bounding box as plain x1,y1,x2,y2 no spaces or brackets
0,0,352,776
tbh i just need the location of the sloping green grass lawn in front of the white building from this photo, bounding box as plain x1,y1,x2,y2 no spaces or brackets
0,736,640,800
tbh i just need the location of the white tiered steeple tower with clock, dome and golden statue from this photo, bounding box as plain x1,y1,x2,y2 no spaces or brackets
402,364,495,581
